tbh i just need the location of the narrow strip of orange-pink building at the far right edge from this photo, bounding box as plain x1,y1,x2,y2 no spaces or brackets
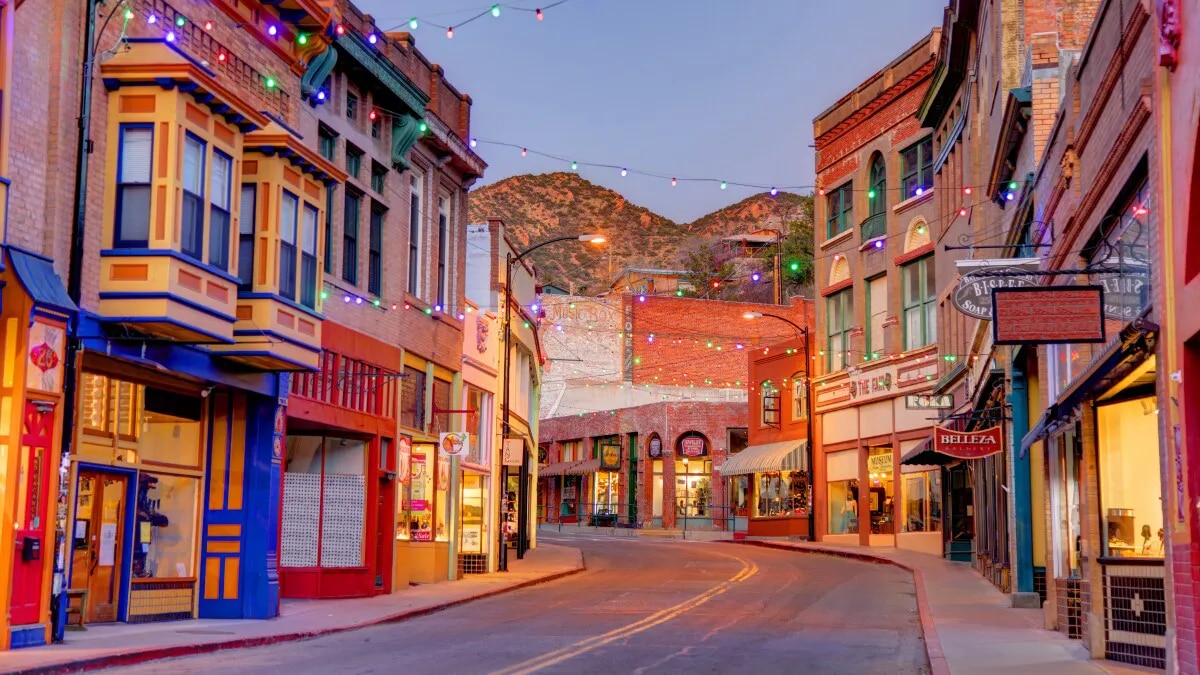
1151,0,1200,673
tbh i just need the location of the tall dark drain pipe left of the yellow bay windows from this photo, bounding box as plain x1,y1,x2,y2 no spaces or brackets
50,0,97,643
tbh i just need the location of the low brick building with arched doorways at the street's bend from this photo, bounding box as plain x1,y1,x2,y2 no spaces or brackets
538,401,746,530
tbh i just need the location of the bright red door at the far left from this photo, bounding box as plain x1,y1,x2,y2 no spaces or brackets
10,402,54,626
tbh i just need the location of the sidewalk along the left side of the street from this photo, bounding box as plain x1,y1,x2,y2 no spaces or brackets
0,544,583,674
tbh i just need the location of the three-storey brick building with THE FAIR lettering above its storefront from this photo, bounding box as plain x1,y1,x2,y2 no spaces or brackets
811,29,946,555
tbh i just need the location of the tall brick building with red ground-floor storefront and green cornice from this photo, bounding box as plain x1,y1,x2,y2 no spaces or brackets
280,1,485,598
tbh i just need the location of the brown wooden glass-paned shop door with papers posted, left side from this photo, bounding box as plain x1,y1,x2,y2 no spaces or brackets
71,467,128,623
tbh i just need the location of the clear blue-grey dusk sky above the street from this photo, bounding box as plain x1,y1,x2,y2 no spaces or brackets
358,0,944,222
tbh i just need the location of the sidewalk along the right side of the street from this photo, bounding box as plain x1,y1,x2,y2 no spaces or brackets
739,539,1147,675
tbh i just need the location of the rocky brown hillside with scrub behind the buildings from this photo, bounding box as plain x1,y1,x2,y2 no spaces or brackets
469,172,809,293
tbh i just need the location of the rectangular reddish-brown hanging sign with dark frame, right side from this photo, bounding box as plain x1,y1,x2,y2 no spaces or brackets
991,286,1104,345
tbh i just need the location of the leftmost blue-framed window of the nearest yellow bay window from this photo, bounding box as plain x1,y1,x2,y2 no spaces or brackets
113,125,154,249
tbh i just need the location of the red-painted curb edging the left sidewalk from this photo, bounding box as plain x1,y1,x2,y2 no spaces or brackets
4,551,587,675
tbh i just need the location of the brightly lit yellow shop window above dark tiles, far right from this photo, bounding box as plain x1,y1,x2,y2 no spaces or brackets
1096,398,1164,557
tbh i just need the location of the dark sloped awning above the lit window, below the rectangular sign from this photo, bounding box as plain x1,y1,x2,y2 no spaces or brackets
1020,315,1158,459
